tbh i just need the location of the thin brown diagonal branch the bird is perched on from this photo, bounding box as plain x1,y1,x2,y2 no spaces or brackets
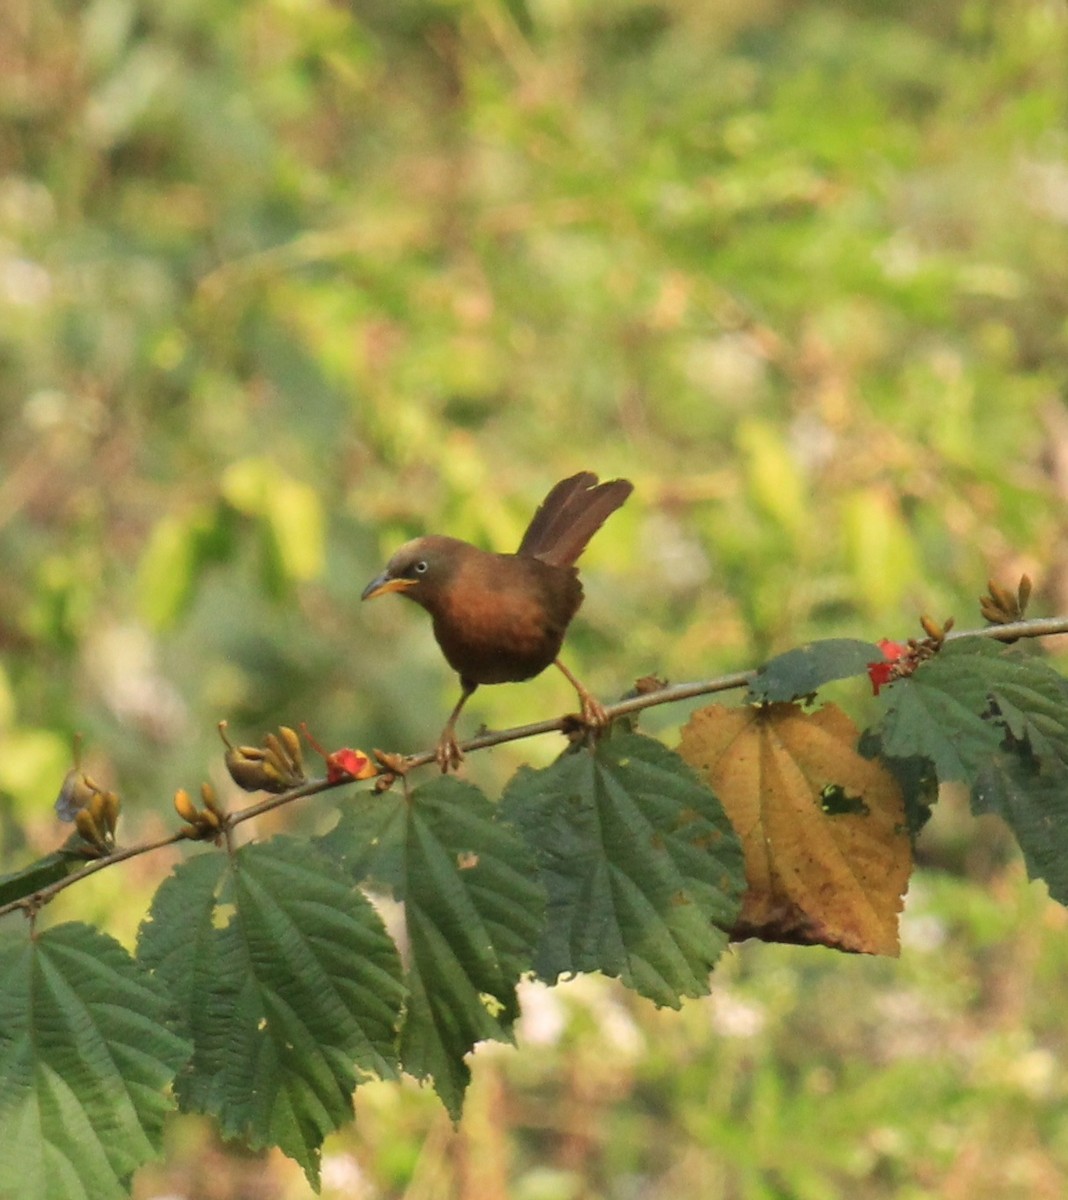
0,617,1068,917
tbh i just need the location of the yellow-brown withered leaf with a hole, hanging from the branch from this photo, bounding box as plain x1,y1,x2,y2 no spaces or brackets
679,704,911,955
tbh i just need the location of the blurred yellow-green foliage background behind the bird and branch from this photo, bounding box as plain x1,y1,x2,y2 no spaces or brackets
0,0,1068,1200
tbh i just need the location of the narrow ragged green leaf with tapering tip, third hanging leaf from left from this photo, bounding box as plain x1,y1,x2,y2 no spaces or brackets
325,779,545,1118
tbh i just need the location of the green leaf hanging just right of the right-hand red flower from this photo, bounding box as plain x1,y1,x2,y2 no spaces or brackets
876,637,1003,784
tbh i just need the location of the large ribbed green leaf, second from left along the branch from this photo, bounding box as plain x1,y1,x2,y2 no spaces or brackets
133,838,403,1186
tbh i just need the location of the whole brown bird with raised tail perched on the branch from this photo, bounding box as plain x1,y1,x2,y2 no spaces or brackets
361,470,634,772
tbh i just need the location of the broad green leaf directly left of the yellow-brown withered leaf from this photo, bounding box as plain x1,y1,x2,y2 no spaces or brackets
503,734,745,1007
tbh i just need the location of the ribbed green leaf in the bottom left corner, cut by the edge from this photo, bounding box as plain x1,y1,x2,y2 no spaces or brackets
0,923,190,1200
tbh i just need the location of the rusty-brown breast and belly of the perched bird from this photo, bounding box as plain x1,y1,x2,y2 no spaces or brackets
432,554,582,684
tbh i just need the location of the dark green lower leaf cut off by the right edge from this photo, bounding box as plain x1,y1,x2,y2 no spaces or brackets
972,754,1068,905
